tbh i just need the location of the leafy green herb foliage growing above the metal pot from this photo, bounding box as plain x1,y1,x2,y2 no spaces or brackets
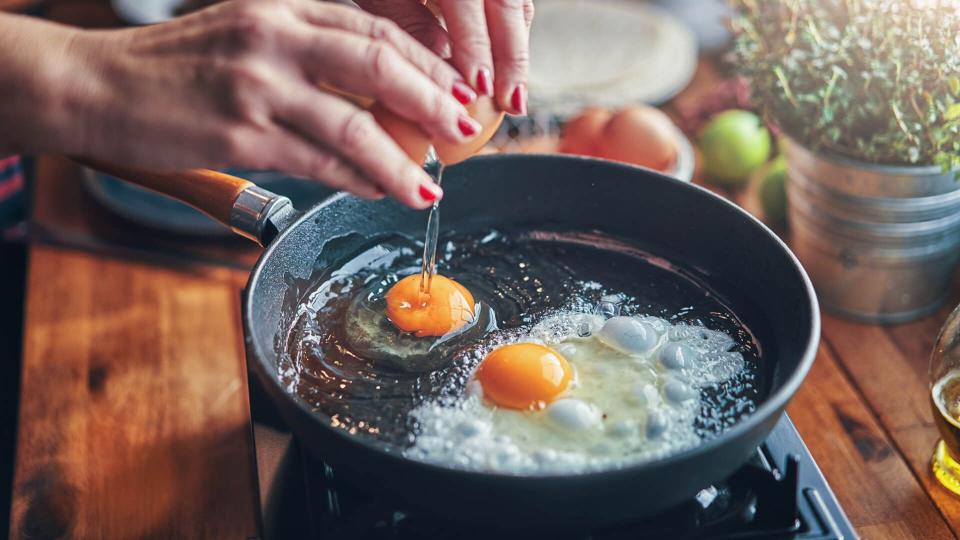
732,0,960,169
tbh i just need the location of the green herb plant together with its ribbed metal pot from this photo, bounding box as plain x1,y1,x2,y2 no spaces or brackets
734,0,960,322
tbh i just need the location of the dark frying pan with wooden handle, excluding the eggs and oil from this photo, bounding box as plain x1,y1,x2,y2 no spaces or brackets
94,155,820,532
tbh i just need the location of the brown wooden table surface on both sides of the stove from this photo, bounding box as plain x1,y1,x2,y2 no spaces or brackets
9,0,960,539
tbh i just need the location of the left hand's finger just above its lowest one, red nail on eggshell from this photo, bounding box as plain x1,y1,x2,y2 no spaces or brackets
295,29,480,143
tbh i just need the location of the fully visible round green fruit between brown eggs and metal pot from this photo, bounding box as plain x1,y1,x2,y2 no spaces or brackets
698,110,773,187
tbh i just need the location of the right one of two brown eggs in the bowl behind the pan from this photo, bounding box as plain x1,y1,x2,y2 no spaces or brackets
598,105,677,172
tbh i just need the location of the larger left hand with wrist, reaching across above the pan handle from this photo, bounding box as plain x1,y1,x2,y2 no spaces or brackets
0,0,496,208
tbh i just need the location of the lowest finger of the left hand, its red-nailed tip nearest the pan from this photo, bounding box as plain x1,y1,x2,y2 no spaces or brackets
276,85,441,208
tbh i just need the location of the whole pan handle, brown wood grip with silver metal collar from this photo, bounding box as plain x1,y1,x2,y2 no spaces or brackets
74,158,299,246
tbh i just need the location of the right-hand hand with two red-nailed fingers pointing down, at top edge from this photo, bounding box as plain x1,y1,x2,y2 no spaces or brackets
355,0,533,114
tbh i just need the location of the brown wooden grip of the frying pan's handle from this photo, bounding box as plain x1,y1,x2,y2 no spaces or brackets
75,159,254,227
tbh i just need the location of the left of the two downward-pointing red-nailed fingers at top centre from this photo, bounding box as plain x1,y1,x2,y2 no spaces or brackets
440,0,493,96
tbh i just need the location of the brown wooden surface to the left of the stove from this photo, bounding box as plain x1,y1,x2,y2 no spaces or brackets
10,247,259,539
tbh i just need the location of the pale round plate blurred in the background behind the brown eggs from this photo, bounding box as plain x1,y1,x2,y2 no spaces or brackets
530,0,697,116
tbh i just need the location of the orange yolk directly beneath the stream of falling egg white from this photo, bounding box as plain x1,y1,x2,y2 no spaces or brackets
386,274,474,337
